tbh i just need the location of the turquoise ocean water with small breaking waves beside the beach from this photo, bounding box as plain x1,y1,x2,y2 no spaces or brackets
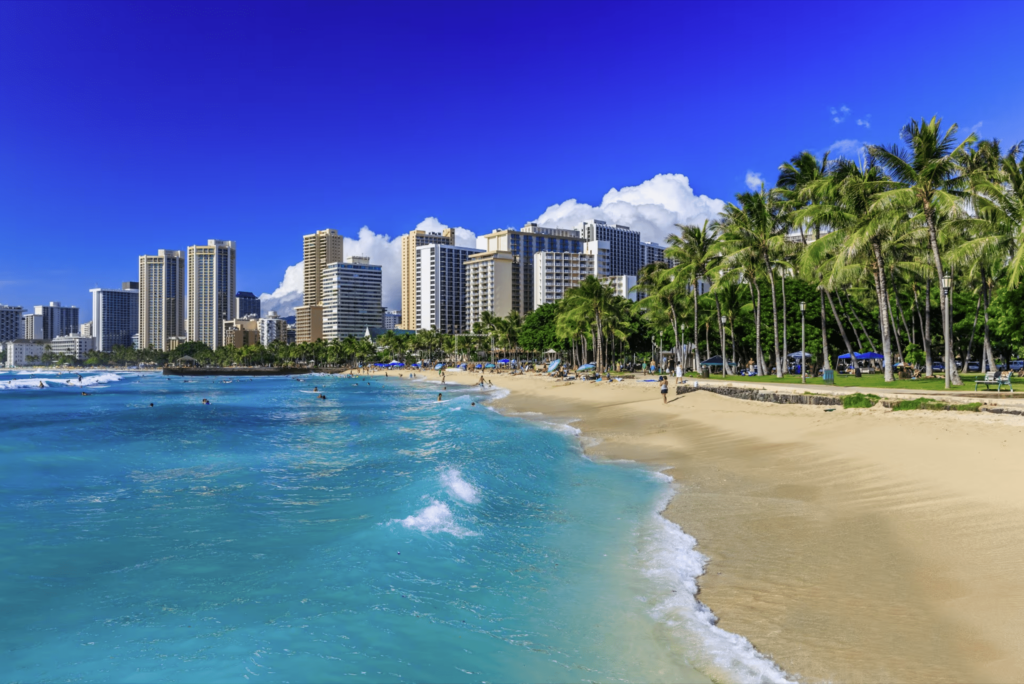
0,373,783,682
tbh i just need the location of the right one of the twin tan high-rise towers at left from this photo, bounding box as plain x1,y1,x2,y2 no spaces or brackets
186,240,238,349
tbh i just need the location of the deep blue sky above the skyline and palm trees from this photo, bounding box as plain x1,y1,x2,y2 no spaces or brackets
0,0,1024,313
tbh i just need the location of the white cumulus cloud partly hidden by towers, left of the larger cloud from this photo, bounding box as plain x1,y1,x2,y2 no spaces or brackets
260,216,476,316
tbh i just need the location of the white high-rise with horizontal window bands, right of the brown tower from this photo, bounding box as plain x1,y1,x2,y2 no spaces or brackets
323,256,384,340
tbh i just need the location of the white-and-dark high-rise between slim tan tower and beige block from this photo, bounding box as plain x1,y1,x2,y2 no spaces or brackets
416,244,481,335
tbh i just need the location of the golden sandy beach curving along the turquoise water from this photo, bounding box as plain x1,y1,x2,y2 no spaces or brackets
415,373,1024,682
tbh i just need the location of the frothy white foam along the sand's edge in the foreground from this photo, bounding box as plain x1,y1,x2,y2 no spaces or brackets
640,485,795,684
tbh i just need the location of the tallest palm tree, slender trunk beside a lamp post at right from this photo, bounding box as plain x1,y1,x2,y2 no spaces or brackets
867,117,977,389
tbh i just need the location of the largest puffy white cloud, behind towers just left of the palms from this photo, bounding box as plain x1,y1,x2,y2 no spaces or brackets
536,173,725,245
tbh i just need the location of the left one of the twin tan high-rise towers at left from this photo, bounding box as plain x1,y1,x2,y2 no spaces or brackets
137,250,186,351
